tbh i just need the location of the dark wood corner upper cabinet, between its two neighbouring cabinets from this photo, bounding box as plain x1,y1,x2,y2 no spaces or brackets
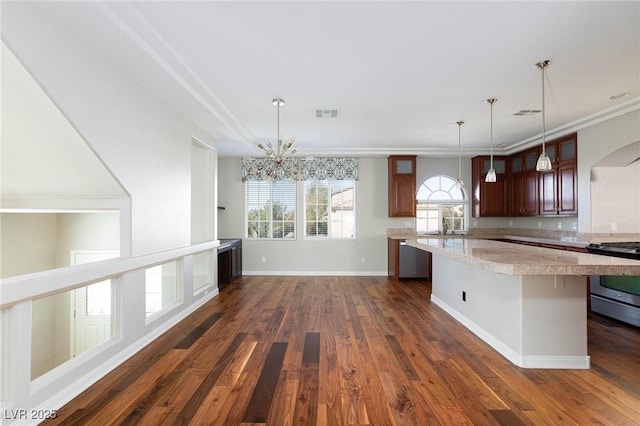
508,148,540,216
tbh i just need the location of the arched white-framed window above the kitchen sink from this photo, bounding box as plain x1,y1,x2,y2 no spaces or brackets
416,175,469,232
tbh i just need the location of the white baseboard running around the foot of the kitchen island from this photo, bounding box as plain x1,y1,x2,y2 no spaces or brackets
431,294,591,370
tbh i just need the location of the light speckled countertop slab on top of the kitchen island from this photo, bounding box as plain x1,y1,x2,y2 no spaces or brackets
407,236,640,275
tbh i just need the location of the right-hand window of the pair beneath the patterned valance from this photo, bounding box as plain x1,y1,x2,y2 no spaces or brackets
304,180,355,238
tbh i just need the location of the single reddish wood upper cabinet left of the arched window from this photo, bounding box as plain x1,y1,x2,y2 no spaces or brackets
389,155,416,217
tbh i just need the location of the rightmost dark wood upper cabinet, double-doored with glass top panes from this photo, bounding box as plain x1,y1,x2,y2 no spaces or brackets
539,133,578,216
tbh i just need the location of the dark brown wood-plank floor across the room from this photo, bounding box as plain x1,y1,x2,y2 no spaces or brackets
47,276,640,426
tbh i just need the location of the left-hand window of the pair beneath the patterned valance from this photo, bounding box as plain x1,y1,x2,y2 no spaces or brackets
245,180,296,239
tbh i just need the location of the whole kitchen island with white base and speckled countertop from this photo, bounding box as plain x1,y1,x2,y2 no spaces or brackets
406,237,640,369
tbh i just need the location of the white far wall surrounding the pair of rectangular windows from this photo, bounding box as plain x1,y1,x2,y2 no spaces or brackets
218,158,390,275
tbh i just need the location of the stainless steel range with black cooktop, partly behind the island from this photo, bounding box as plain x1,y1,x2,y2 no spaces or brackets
587,242,640,327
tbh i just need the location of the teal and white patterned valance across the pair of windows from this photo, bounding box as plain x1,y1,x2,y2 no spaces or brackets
242,157,358,181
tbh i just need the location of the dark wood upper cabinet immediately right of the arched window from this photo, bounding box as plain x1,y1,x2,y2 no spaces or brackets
471,156,509,217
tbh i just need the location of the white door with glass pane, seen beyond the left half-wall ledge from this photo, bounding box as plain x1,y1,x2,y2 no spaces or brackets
70,250,120,357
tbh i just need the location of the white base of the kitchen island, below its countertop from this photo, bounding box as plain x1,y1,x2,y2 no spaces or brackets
431,254,589,369
